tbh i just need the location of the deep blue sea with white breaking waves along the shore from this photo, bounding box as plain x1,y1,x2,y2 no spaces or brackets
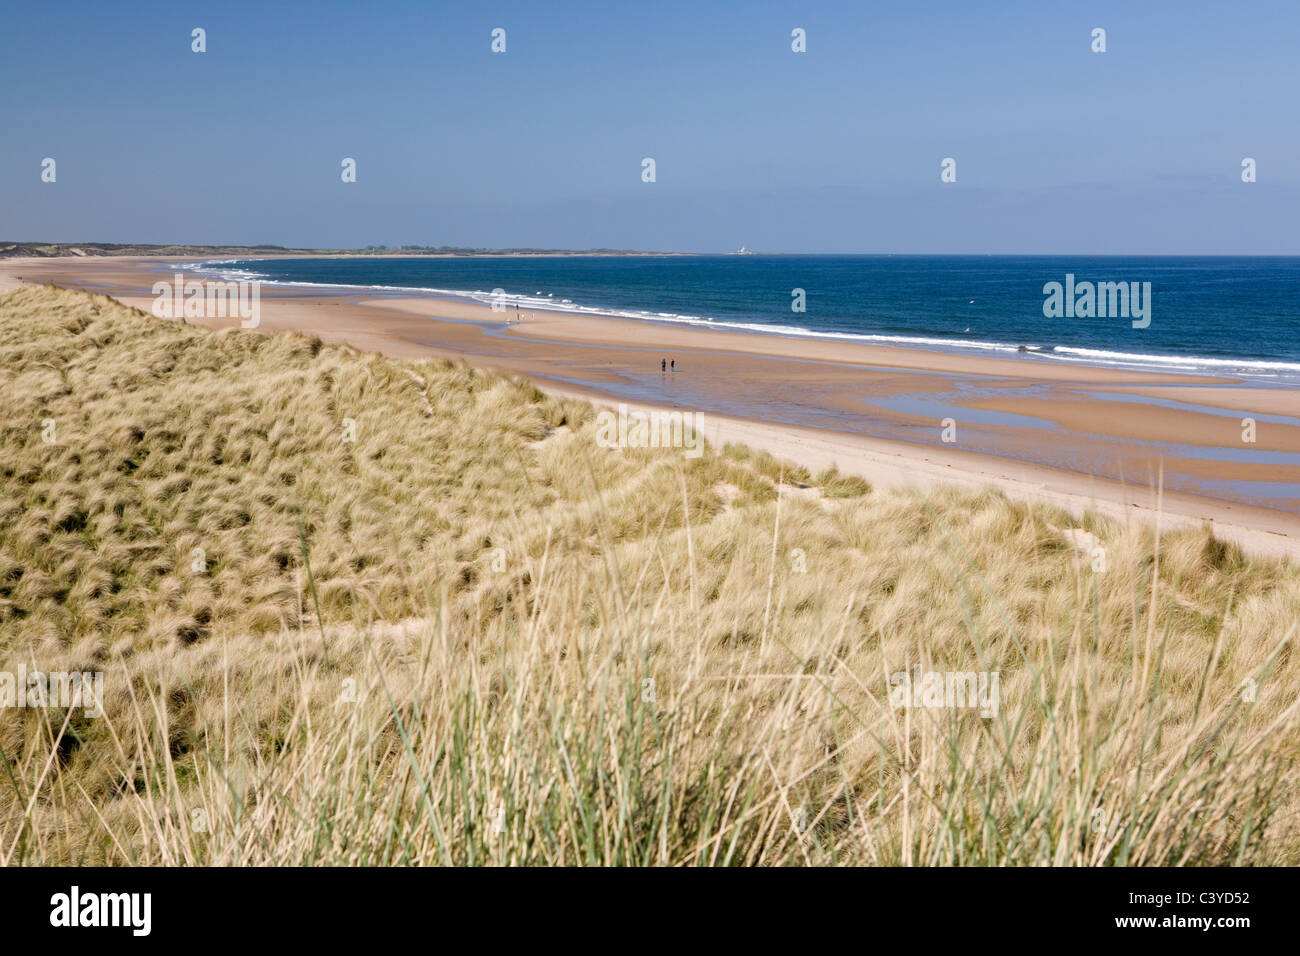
192,255,1300,384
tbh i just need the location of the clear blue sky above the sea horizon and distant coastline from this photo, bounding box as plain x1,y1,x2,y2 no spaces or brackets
0,0,1300,254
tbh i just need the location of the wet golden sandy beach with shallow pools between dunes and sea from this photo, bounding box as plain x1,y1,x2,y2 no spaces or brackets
10,258,1300,554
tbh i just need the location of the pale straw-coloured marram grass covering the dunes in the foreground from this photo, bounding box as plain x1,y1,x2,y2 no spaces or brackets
0,287,1300,866
